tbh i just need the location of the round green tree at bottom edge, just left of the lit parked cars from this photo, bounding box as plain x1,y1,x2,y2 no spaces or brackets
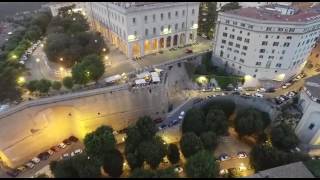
185,151,219,178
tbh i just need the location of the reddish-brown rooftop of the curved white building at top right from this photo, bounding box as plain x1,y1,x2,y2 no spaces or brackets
225,4,320,22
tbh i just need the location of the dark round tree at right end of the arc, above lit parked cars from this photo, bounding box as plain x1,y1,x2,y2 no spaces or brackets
235,109,263,137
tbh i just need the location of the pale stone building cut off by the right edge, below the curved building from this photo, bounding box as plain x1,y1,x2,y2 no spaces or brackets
295,75,320,145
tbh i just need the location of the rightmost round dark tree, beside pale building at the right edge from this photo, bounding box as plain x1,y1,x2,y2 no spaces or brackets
271,123,299,151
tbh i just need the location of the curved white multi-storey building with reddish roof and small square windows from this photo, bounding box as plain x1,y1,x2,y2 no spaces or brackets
213,4,320,86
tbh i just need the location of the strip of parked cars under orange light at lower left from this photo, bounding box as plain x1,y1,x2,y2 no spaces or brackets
0,139,84,178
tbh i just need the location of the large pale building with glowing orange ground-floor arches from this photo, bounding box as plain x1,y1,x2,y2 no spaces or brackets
88,2,200,58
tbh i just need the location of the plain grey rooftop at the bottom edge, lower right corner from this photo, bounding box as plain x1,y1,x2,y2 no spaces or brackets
247,162,314,178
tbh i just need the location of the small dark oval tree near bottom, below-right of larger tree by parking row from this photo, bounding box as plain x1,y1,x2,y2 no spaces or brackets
103,149,124,177
